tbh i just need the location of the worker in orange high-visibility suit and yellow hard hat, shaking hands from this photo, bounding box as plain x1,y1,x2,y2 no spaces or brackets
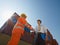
7,14,33,45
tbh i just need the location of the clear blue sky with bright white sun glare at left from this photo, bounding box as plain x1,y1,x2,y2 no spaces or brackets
0,0,60,43
